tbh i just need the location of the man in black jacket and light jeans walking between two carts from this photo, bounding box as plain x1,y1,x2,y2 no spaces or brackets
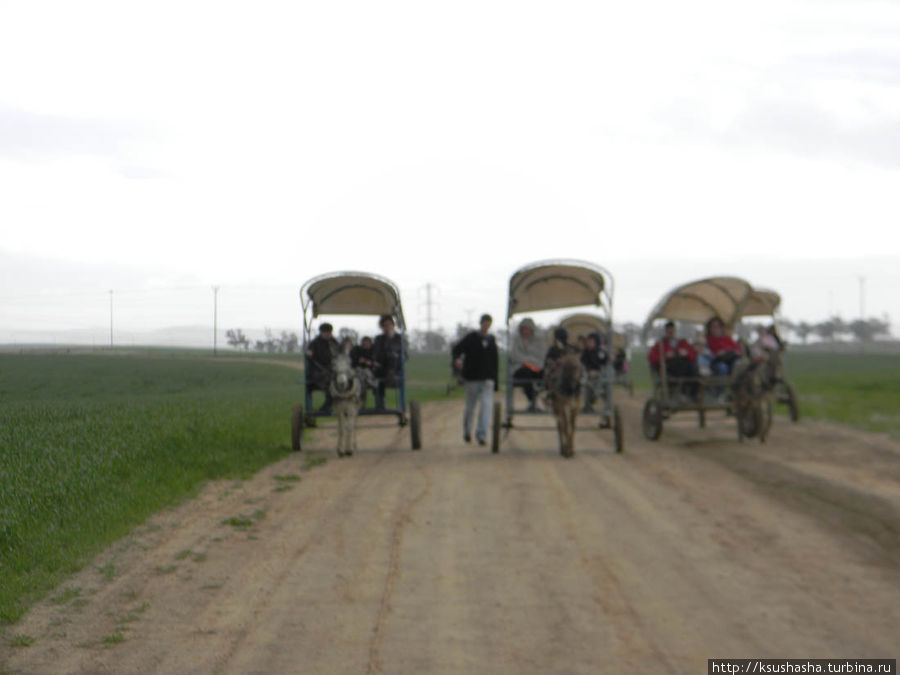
451,314,500,445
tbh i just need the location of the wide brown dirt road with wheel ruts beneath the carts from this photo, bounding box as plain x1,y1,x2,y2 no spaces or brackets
0,400,900,674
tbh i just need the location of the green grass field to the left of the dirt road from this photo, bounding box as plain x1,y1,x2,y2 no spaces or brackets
0,354,300,625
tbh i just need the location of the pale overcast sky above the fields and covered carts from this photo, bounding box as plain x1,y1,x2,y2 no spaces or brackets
0,0,900,341
